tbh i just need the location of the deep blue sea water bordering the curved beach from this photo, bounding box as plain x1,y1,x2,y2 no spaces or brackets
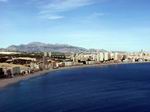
0,64,150,112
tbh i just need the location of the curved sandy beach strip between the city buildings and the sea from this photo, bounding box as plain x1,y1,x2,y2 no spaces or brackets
0,62,150,89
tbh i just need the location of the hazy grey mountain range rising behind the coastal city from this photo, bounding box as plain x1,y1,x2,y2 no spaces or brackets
0,42,105,53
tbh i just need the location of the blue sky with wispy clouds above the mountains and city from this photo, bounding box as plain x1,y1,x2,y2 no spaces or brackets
0,0,150,51
